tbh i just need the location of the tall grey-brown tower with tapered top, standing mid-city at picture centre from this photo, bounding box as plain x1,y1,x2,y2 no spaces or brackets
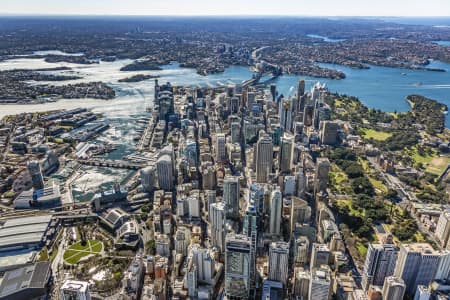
255,134,273,183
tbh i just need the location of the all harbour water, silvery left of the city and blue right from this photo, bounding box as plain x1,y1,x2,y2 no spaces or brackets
0,54,450,201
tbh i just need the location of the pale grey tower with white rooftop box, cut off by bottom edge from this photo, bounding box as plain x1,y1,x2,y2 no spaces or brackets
309,265,331,300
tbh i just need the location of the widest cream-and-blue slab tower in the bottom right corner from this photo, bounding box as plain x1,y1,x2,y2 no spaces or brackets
394,243,440,296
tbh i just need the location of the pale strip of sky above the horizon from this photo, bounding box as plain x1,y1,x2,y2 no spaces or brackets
0,0,450,17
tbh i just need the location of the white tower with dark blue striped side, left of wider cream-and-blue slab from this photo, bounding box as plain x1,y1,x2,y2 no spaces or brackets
362,244,398,291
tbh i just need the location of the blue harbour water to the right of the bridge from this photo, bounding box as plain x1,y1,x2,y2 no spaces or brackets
268,61,450,127
